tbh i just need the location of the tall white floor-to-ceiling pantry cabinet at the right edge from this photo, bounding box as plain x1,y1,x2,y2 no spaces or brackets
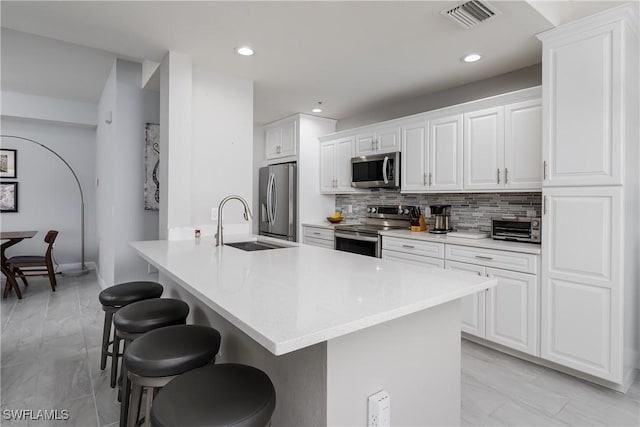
538,5,640,390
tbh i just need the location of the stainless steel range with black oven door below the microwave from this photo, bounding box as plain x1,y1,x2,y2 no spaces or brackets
335,205,414,258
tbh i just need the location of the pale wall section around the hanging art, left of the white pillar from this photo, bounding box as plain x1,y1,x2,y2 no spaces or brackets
96,60,160,286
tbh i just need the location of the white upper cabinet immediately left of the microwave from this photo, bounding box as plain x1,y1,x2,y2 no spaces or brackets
320,137,355,194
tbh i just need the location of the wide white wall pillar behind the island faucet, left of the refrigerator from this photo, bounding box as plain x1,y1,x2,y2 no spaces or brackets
160,52,253,239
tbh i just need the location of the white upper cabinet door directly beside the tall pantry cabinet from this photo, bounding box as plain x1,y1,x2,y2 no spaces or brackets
504,99,542,190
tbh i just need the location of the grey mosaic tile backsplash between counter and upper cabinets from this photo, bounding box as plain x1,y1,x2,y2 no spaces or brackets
336,190,542,231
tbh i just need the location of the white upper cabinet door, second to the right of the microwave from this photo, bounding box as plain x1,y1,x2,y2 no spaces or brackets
428,114,462,191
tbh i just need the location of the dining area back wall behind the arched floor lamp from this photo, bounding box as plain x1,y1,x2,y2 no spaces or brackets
0,117,97,268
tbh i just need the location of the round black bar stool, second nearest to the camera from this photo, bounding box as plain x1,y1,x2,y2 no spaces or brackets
121,325,220,427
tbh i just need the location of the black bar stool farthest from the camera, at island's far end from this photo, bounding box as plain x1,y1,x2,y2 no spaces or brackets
98,282,164,388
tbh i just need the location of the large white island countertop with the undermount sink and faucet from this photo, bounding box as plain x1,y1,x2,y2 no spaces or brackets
131,235,497,355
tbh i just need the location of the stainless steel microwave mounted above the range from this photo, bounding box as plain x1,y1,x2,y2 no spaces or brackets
351,152,400,188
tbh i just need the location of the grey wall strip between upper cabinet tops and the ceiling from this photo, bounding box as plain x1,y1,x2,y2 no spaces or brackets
336,64,542,131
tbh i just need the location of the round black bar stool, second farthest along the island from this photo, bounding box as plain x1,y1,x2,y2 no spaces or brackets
113,298,189,425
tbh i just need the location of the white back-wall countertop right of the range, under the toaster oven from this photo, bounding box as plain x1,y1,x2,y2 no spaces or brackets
381,230,542,255
